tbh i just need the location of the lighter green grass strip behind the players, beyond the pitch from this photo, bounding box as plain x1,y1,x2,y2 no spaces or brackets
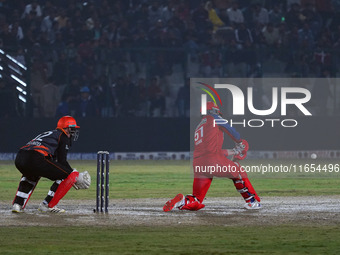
0,160,340,201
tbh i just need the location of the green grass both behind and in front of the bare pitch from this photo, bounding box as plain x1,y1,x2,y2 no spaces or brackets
0,160,340,254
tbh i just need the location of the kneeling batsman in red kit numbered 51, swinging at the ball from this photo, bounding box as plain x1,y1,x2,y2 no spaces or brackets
163,102,261,212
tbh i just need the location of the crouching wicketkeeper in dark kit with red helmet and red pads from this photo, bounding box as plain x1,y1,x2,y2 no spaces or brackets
12,116,91,213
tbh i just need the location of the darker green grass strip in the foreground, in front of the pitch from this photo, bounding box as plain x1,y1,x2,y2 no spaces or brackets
0,226,340,255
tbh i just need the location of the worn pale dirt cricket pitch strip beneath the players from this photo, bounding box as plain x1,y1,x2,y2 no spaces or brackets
0,195,340,227
